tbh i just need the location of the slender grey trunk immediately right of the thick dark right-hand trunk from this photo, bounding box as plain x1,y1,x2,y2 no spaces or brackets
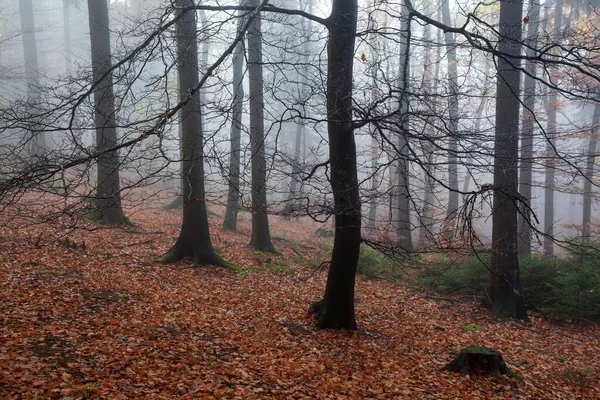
518,0,540,257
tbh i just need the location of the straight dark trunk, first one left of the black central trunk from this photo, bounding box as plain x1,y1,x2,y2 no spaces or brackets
248,0,275,251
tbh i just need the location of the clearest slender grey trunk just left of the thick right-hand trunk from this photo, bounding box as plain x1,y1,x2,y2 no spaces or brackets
442,0,459,239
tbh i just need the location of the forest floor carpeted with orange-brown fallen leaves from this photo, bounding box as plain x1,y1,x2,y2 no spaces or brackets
0,198,600,400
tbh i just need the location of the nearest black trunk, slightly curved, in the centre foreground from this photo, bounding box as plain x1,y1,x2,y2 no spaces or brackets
317,0,361,329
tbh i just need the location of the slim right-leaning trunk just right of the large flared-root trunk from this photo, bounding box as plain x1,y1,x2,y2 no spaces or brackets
223,6,244,231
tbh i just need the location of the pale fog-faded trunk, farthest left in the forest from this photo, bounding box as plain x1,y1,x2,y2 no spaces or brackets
19,0,46,157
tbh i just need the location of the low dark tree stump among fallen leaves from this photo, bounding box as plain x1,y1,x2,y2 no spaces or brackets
443,345,510,376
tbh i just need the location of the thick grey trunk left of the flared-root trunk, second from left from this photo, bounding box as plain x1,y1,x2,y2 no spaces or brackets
88,0,128,224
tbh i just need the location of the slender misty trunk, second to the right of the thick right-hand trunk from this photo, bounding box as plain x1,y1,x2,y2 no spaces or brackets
544,1,562,257
